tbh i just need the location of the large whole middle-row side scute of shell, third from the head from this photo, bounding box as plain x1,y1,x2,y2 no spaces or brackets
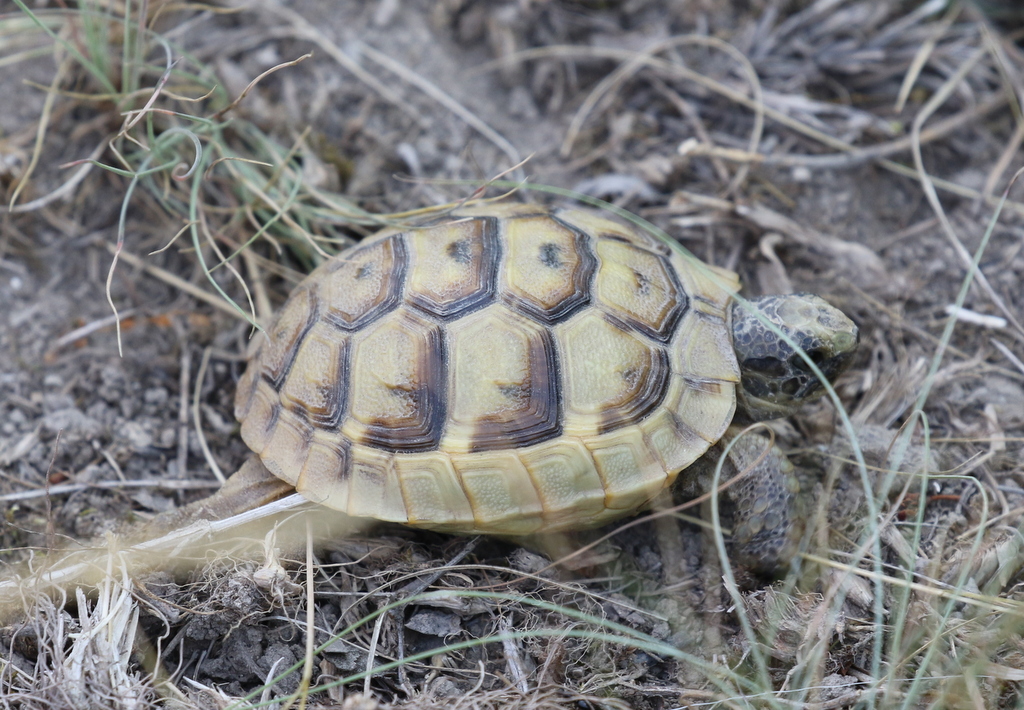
342,310,446,452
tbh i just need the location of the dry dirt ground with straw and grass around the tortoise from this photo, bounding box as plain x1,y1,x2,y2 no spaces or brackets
0,0,1024,710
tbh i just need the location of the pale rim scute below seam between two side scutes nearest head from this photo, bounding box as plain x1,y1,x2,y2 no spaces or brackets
519,436,605,532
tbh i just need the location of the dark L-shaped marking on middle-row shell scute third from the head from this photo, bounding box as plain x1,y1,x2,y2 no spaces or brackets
358,325,449,453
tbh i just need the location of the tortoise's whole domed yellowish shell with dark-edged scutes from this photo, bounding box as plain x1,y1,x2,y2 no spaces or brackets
236,205,739,535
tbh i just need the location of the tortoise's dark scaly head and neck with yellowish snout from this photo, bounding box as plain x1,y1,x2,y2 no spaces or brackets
732,293,860,421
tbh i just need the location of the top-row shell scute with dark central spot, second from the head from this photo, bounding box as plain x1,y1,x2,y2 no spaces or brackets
503,216,597,324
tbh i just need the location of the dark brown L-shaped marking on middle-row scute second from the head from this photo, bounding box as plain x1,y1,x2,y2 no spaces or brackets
470,330,562,452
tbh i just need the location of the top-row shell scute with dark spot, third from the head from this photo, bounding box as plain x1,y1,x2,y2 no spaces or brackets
406,218,500,318
